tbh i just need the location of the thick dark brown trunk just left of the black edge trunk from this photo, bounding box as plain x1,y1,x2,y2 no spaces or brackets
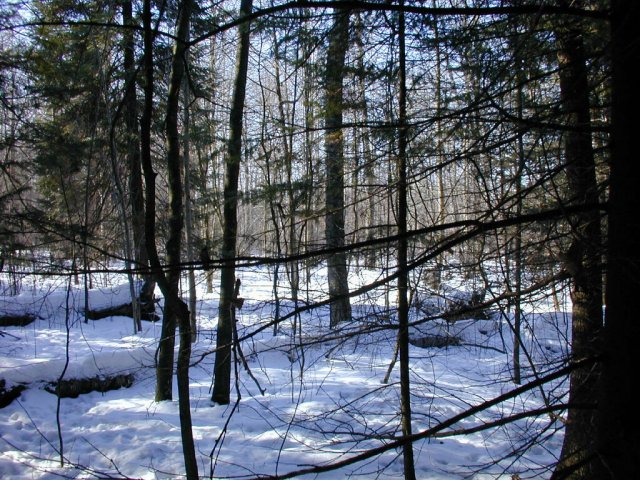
554,15,602,479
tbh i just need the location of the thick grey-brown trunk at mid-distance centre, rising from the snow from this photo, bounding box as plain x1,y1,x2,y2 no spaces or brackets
325,3,351,328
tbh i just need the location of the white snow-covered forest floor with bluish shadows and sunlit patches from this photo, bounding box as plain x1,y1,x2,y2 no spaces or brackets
0,269,568,479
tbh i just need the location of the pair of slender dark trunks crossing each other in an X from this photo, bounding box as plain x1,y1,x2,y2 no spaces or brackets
140,0,198,472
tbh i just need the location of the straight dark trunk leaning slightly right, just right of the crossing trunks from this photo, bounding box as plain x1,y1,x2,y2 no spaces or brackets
211,0,253,405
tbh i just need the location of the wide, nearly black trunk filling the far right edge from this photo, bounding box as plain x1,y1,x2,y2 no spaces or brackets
592,0,640,479
